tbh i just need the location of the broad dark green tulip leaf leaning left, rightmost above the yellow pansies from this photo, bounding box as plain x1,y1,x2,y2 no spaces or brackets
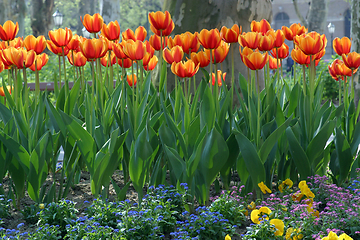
286,127,311,180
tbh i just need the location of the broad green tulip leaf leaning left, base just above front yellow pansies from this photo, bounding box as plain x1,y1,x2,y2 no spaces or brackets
235,131,265,187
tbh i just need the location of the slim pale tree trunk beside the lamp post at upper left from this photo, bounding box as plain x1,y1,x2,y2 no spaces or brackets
31,0,54,37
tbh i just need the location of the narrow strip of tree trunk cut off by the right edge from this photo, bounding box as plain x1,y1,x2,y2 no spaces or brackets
351,0,360,104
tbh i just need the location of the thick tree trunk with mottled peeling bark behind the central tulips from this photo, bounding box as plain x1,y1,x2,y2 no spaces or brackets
164,0,272,95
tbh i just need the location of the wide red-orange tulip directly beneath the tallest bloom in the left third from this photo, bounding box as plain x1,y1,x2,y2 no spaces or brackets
80,38,108,61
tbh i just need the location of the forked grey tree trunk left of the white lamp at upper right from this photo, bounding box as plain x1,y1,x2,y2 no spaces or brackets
293,0,328,34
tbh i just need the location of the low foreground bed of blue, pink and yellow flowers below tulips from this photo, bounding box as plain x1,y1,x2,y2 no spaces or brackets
0,172,360,240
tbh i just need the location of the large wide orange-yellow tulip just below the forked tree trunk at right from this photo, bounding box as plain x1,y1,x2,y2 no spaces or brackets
294,32,327,55
